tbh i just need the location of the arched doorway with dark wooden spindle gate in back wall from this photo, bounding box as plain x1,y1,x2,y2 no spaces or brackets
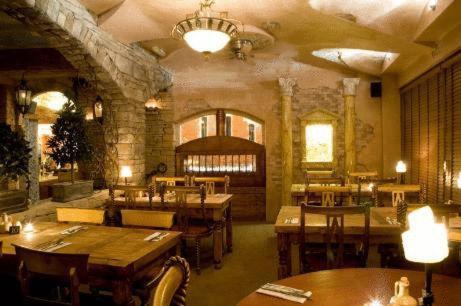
175,109,266,221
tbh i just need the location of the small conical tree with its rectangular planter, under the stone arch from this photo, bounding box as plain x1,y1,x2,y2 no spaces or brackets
48,100,93,202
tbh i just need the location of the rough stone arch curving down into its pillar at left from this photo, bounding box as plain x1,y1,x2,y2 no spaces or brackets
0,0,171,181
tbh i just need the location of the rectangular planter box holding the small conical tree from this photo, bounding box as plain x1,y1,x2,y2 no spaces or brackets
52,181,93,203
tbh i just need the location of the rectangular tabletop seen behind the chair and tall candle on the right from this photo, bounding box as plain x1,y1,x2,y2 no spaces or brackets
275,206,461,235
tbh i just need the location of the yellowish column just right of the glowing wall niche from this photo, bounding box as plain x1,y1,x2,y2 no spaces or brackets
343,78,360,175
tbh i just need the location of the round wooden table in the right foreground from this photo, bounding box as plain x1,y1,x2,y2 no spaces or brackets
238,268,461,306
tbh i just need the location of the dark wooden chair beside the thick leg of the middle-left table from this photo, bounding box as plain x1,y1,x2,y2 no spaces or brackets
160,184,214,274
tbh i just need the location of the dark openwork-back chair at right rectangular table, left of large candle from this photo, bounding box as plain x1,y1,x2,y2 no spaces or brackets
299,203,370,273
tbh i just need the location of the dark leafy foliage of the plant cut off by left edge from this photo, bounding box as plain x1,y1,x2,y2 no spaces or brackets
0,123,32,183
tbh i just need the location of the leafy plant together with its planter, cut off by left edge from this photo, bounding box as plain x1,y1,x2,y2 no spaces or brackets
0,123,32,212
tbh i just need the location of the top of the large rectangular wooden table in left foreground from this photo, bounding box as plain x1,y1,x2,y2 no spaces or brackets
0,222,181,267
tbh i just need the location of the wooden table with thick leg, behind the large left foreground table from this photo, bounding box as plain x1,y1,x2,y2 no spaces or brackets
109,194,233,269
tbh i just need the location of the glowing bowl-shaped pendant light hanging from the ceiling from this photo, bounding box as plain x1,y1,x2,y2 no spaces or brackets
171,0,238,55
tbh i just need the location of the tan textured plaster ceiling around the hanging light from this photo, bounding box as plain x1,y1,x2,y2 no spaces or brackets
70,0,461,75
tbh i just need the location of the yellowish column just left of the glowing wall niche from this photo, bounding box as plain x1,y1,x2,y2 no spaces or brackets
279,78,296,205
